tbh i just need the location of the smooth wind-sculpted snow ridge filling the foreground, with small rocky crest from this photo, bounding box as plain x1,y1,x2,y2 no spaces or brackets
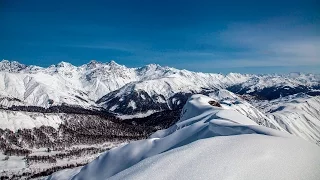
48,95,320,180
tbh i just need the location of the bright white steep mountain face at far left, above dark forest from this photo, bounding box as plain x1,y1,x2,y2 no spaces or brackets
0,72,94,107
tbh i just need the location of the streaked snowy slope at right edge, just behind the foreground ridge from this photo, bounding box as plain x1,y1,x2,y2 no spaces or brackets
254,93,320,145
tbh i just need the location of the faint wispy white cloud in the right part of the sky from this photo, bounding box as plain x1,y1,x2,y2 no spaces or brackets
214,18,320,66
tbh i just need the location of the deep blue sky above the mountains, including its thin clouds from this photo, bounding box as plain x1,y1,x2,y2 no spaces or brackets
0,0,320,73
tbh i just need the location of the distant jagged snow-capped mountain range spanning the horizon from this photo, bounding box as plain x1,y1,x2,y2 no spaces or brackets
0,60,320,110
